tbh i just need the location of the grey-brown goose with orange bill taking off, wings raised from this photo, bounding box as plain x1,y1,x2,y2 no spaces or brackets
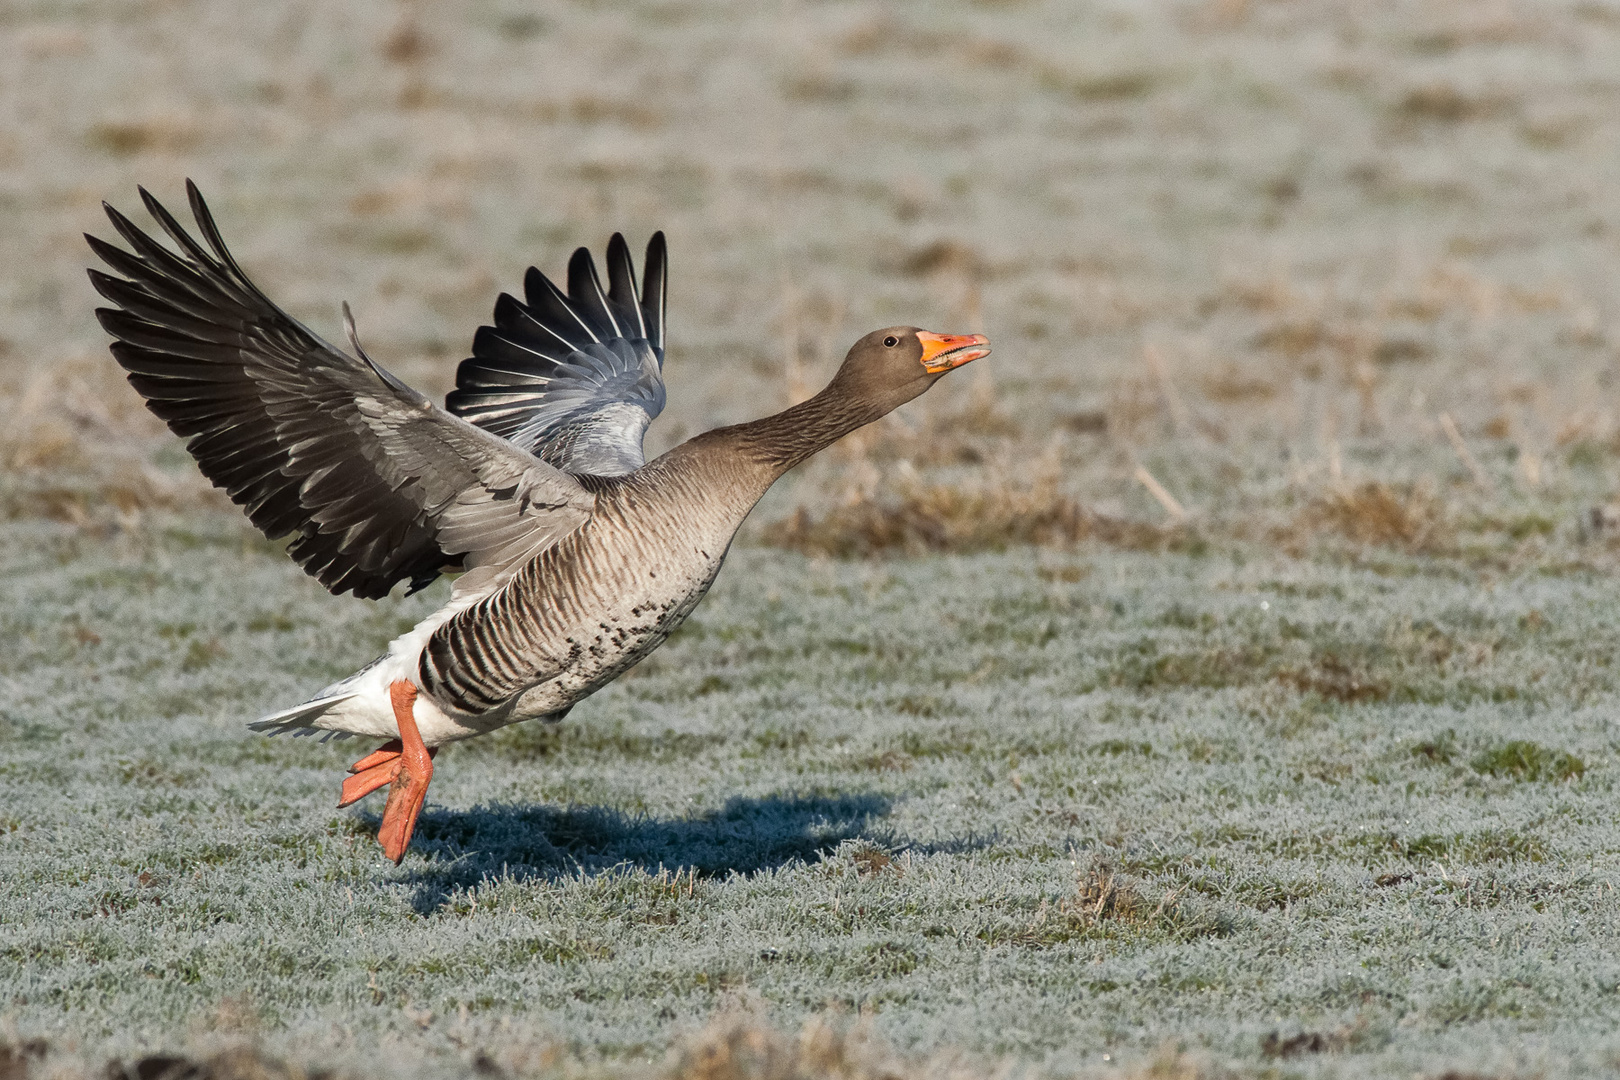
86,180,990,865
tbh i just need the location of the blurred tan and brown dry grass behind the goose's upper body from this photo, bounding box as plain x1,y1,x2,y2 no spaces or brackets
0,0,1620,557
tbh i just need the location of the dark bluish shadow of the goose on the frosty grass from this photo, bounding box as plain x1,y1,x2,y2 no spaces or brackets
379,793,939,915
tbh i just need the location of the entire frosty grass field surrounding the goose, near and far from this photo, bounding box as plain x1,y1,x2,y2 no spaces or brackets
0,0,1620,1080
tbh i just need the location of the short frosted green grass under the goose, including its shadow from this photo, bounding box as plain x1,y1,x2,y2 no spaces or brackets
9,520,1620,1075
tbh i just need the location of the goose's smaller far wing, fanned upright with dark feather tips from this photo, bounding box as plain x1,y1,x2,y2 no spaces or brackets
444,233,666,476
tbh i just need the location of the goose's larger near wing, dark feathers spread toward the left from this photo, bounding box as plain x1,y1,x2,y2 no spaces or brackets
86,187,595,608
